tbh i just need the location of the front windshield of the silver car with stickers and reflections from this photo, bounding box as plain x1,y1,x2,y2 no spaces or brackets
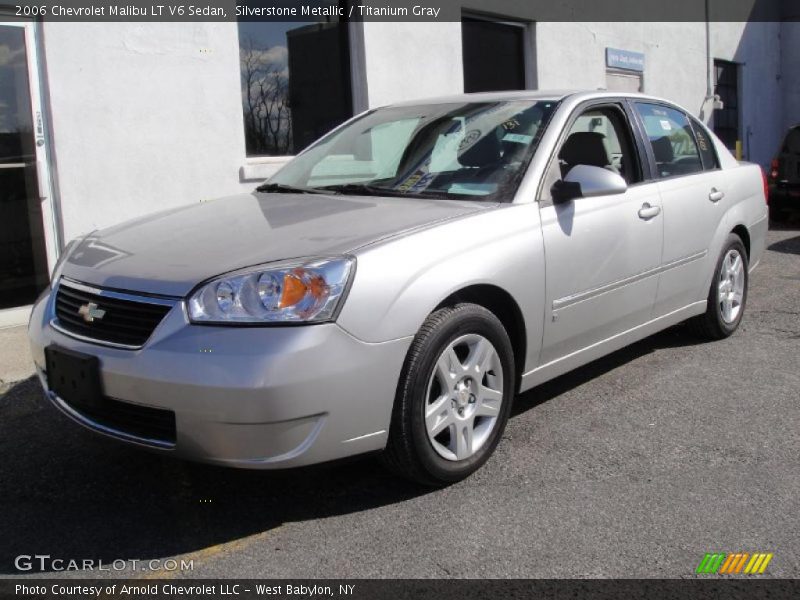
262,100,556,201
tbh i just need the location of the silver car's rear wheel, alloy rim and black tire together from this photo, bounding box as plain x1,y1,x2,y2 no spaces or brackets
691,233,749,340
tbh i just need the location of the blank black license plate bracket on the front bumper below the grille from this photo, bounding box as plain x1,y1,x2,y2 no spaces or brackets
44,345,103,409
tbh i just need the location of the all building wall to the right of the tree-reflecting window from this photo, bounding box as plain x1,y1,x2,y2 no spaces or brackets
364,20,800,166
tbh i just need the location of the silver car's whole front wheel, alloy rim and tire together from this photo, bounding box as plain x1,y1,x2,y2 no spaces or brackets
385,304,515,486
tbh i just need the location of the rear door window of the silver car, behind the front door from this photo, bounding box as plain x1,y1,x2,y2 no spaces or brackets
636,102,709,179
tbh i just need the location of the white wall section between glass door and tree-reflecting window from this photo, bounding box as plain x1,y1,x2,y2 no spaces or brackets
43,22,245,240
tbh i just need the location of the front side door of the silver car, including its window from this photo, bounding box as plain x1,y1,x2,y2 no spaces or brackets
539,101,663,365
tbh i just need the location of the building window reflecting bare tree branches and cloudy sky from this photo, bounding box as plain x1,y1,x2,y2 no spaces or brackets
239,7,353,156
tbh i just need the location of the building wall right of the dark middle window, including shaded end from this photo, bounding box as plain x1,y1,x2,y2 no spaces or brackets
536,23,784,165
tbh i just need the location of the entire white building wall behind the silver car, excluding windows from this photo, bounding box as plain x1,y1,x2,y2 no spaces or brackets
43,15,800,244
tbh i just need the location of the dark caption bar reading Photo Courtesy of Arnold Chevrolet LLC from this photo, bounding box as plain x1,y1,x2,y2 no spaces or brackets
0,576,800,600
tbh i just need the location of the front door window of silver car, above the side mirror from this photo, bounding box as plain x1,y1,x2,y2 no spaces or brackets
558,106,642,185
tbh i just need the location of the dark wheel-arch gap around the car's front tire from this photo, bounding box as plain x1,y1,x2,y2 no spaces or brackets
434,283,528,393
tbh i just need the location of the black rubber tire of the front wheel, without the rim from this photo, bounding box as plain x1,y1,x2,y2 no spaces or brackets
383,304,516,487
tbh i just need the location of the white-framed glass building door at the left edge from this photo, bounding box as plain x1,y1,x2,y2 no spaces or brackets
0,23,55,326
